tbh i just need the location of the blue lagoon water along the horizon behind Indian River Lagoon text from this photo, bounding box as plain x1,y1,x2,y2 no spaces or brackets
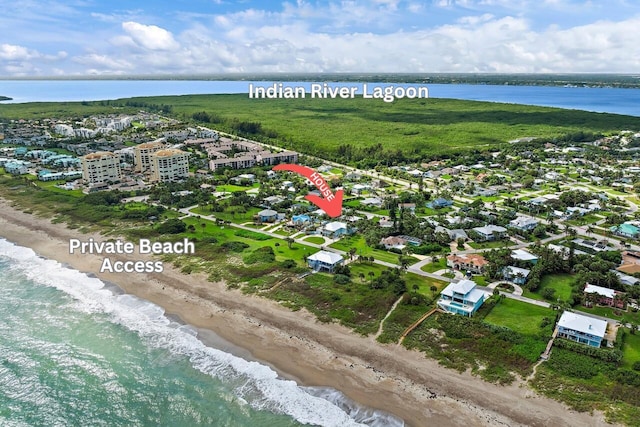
0,80,640,116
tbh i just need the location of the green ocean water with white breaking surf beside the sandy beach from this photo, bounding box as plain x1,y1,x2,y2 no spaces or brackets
0,239,403,427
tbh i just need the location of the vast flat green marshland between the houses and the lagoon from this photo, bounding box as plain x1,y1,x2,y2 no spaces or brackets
5,94,640,160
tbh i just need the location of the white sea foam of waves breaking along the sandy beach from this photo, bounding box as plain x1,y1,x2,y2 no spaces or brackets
0,239,403,426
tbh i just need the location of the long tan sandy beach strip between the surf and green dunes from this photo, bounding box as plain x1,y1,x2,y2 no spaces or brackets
0,199,609,427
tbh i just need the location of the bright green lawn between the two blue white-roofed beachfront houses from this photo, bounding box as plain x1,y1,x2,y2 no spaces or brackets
484,298,555,337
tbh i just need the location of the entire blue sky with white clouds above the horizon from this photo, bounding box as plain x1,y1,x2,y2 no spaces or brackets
0,0,640,76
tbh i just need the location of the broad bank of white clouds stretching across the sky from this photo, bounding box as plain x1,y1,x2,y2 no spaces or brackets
0,0,640,74
